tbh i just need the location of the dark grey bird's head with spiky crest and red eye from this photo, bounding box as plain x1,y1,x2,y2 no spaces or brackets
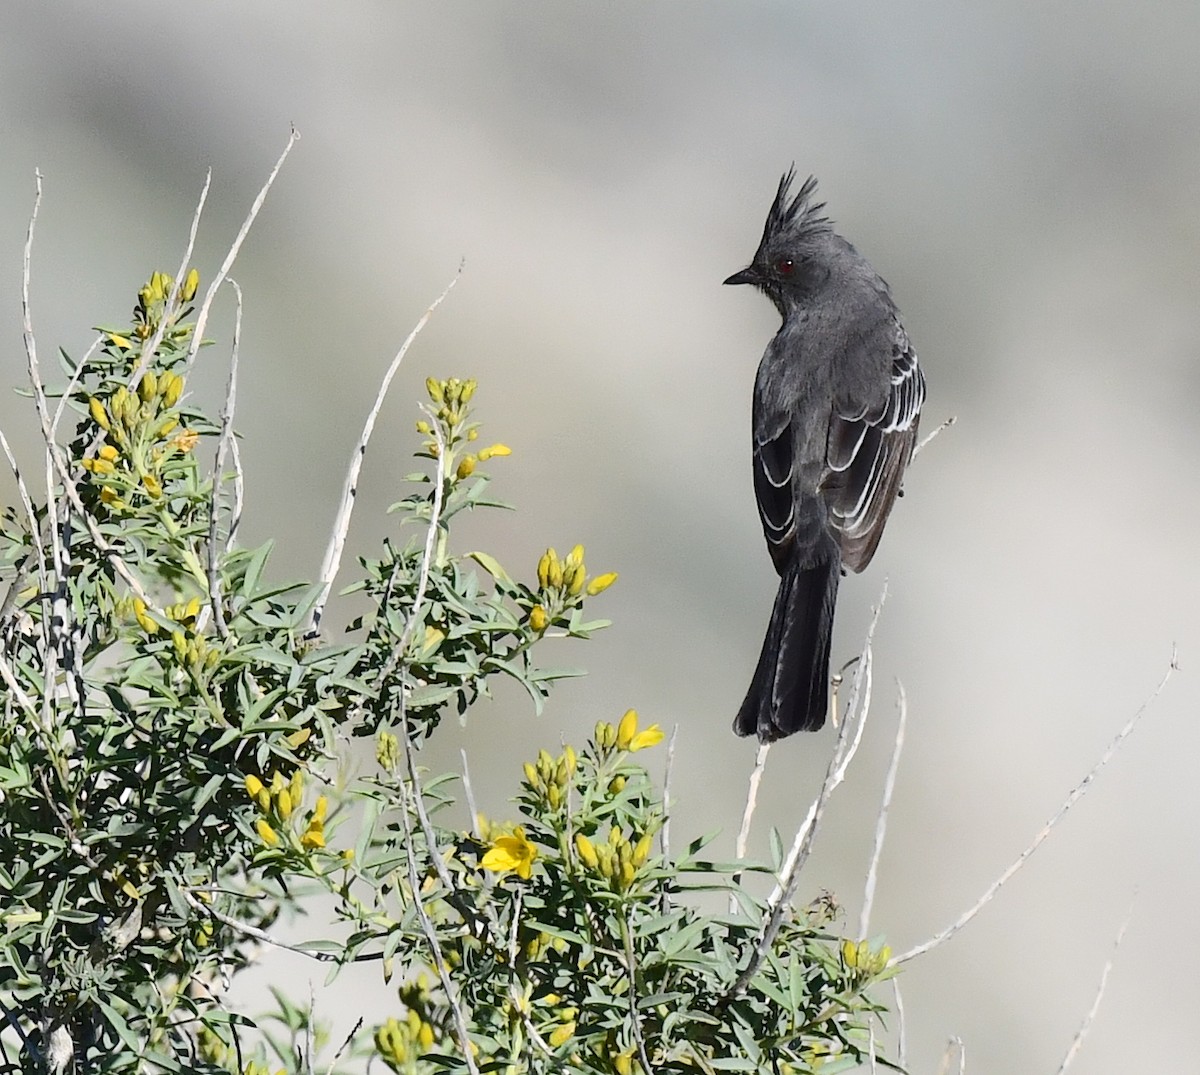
725,164,839,317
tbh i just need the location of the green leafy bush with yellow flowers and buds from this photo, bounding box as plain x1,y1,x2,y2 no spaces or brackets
0,262,889,1075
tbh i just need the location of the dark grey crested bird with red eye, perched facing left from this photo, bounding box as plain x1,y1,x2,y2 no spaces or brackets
725,167,925,743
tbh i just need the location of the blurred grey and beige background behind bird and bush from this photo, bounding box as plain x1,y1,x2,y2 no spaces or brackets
0,0,1200,1075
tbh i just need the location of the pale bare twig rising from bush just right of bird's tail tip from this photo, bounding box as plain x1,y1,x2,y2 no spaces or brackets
727,582,888,996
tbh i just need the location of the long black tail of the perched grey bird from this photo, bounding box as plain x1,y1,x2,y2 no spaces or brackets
733,557,841,743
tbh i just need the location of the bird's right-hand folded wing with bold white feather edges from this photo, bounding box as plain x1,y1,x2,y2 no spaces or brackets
822,320,925,571
